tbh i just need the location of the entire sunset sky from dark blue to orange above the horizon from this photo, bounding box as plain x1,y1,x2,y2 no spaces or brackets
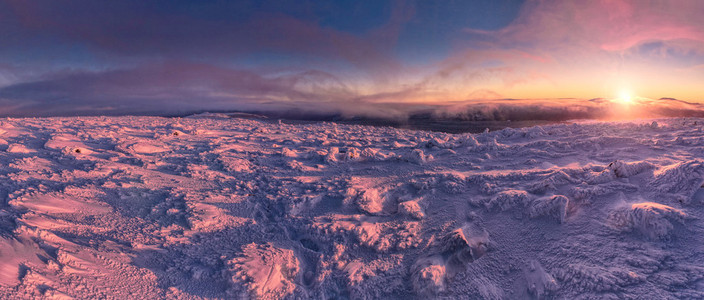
0,0,704,116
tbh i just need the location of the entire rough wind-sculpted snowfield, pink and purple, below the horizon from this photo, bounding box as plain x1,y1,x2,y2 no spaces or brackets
0,117,704,299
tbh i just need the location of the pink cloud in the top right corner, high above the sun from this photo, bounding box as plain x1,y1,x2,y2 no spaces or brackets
469,0,704,54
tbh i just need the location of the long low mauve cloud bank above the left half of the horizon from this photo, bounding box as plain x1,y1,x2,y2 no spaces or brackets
0,62,338,115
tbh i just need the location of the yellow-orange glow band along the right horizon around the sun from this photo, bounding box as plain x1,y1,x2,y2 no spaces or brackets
382,59,704,104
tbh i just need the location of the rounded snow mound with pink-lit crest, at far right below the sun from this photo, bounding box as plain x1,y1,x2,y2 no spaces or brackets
610,202,687,239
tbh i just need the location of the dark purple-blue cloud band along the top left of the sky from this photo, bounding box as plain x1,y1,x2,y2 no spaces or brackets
0,0,409,72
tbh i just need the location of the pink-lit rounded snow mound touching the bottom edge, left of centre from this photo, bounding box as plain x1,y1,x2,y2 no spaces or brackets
228,243,300,299
